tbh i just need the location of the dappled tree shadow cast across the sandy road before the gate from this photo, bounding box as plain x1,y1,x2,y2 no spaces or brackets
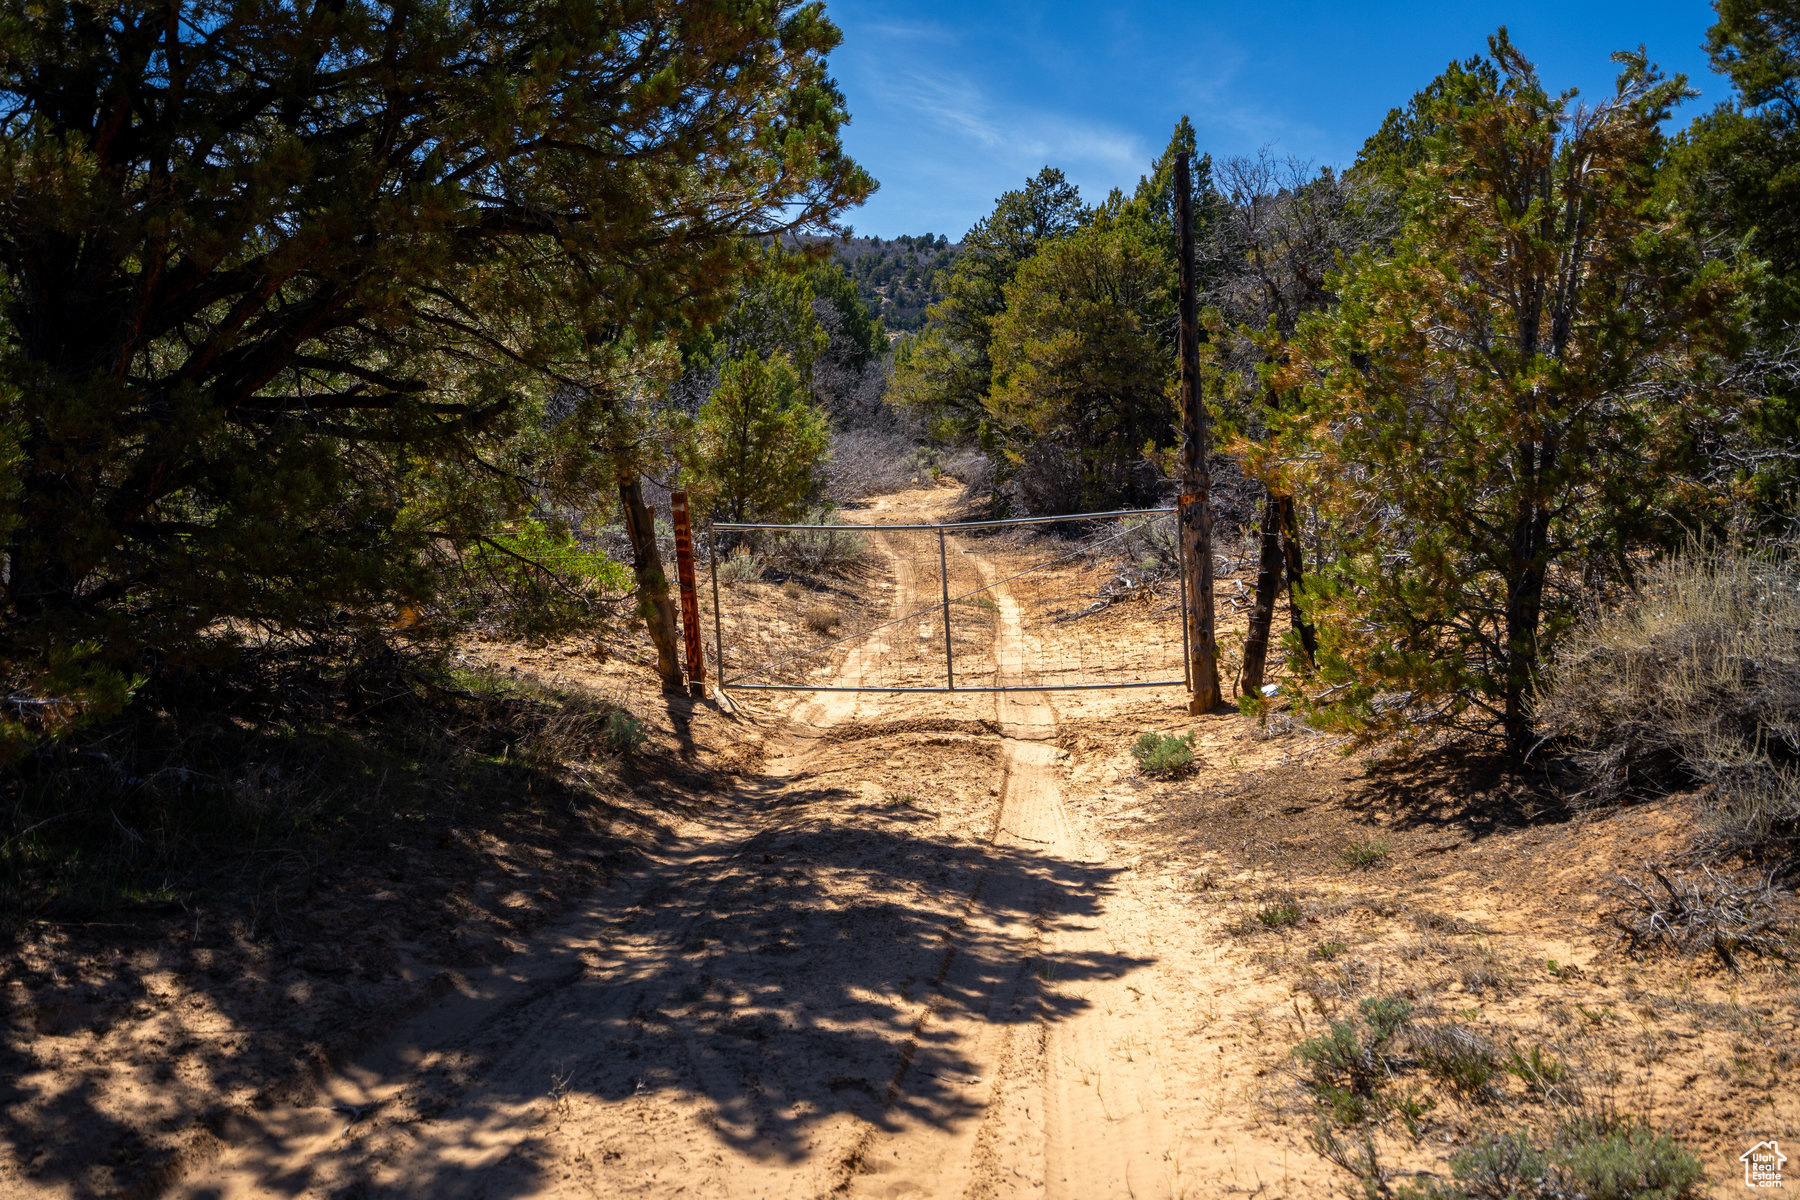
169,766,1145,1196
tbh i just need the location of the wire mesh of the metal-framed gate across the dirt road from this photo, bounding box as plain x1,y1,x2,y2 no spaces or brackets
711,509,1186,691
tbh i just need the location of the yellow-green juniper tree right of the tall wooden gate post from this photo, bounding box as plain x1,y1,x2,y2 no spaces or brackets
1264,31,1742,750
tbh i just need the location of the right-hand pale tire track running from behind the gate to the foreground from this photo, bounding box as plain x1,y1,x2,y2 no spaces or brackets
848,563,1181,1200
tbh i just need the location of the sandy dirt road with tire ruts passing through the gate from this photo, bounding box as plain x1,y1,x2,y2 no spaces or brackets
162,489,1316,1200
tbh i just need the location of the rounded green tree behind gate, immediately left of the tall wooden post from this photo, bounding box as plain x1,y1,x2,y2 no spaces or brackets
986,221,1175,513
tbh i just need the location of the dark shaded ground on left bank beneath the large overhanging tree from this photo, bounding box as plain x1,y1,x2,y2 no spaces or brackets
0,647,702,1196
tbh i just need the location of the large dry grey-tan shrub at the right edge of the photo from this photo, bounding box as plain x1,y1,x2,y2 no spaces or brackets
1537,547,1800,853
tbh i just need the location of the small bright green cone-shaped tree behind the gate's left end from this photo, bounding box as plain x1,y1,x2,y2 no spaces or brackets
689,354,832,522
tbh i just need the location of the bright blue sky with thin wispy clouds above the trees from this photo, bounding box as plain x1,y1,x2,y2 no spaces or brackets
828,0,1728,239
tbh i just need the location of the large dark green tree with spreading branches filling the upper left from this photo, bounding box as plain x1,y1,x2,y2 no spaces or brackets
0,0,871,741
